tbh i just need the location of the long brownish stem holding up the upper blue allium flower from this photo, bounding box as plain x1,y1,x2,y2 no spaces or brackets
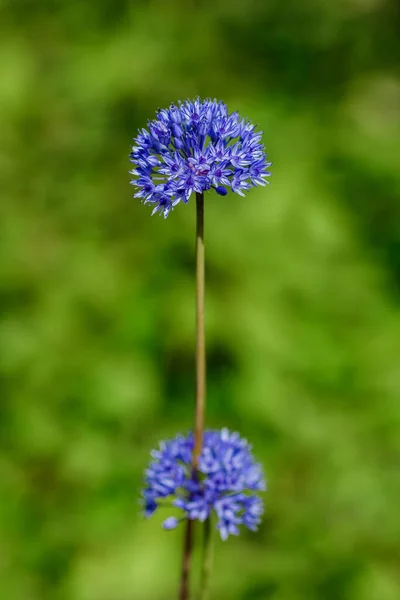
179,193,206,600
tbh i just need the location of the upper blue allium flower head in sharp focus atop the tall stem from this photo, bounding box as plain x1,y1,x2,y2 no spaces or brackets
130,99,271,217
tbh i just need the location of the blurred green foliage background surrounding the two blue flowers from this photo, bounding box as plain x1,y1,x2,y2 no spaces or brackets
0,0,400,600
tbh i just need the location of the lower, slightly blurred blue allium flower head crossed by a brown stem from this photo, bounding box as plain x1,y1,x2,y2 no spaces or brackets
143,429,266,540
